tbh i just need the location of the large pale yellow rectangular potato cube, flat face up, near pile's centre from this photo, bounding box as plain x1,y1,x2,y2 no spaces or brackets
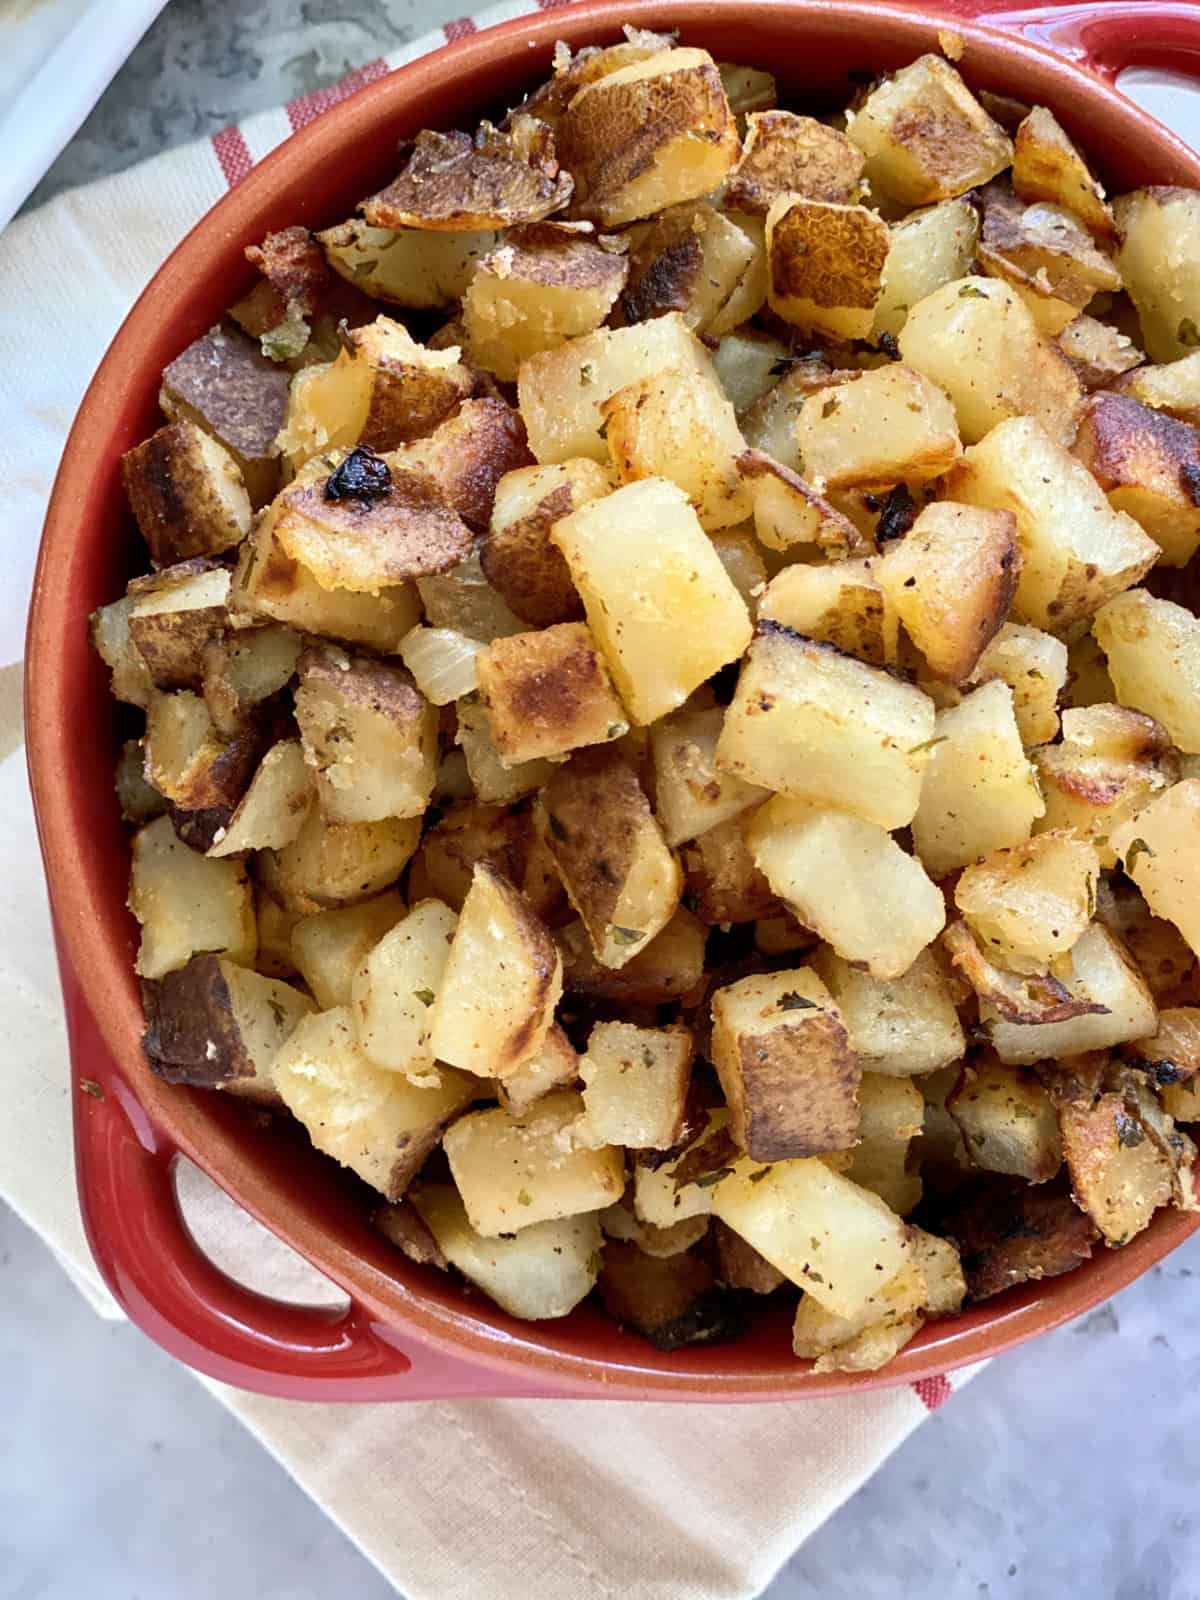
550,478,750,725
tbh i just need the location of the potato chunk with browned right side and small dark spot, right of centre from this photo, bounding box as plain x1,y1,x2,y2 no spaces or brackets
875,501,1021,683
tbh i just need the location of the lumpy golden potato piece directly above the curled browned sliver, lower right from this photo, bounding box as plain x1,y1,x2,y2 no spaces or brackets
954,832,1099,973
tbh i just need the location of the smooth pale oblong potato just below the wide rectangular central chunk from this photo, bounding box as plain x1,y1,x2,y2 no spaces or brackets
750,795,946,978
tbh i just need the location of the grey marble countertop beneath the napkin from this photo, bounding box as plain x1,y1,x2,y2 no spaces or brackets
9,0,1200,1600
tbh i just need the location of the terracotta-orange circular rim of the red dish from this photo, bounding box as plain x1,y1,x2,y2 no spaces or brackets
26,0,1200,1400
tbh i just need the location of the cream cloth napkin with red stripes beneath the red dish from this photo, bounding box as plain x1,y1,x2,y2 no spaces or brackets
11,0,1192,1600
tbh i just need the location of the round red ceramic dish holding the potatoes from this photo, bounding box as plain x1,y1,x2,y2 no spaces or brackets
26,0,1200,1400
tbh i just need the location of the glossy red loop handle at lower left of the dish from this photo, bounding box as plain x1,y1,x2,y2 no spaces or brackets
61,962,546,1400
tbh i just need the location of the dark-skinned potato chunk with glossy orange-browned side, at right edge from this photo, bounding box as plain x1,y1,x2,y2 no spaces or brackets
1075,394,1200,566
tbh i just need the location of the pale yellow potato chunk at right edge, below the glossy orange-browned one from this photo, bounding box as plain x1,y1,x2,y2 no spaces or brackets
1093,589,1200,754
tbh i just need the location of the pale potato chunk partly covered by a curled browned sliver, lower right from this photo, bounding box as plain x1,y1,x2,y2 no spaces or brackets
979,922,1155,1066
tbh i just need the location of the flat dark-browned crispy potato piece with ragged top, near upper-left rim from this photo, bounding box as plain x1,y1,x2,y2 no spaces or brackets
360,117,573,232
